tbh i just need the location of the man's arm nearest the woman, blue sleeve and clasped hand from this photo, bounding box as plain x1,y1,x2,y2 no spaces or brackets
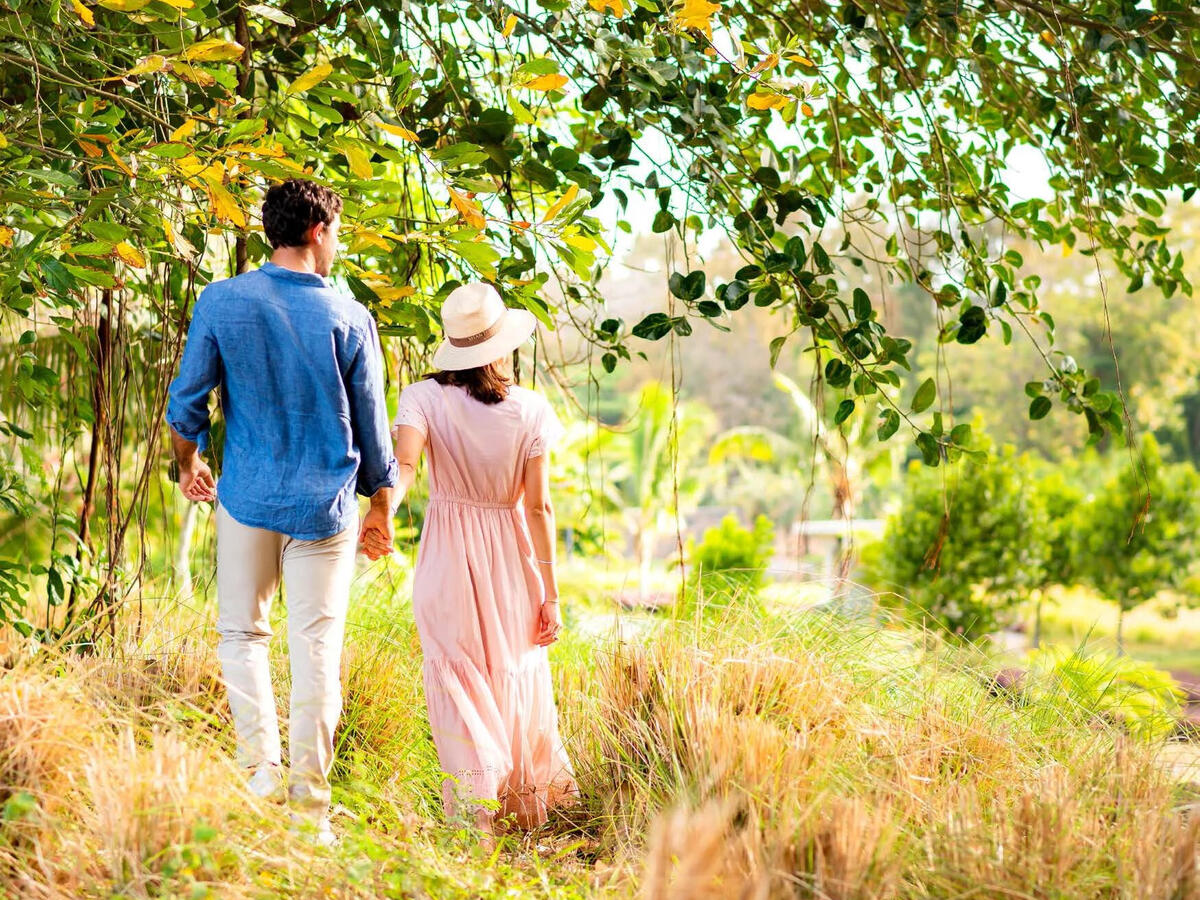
346,316,398,559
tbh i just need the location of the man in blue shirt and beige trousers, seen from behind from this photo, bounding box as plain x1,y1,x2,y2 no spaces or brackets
167,180,397,842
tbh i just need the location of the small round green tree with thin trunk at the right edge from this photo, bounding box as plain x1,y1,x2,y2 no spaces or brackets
1076,434,1200,653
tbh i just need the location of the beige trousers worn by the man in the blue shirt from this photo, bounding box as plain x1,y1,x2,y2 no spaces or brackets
217,506,358,815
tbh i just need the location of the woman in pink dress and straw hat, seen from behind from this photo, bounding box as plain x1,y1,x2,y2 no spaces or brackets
374,284,576,835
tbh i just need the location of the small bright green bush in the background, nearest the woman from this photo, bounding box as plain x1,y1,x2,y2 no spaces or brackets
680,516,775,612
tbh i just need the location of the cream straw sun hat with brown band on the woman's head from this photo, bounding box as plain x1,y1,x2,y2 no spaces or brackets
433,282,538,372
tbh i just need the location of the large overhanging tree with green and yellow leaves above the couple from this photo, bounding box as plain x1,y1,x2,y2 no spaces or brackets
0,0,1200,634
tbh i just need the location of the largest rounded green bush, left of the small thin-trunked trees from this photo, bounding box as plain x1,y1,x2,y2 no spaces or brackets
878,446,1046,640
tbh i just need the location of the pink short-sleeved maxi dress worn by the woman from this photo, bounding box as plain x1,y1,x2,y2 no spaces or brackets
396,379,577,828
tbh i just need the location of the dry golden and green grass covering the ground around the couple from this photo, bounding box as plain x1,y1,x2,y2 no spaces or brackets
0,585,1200,900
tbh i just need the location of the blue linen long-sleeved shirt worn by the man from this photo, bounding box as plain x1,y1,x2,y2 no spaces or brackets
167,263,397,540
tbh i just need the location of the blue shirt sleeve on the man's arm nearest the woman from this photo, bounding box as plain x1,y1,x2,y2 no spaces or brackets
346,314,400,497
